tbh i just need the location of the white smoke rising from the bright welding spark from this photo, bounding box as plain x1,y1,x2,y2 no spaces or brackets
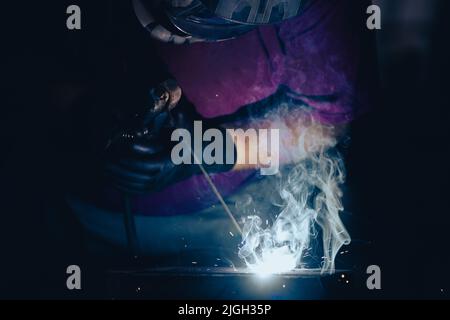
236,110,350,274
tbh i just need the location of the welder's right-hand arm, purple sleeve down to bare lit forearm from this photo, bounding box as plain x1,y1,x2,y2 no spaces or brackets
223,0,377,170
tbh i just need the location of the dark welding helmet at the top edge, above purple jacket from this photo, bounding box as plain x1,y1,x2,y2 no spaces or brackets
133,0,312,43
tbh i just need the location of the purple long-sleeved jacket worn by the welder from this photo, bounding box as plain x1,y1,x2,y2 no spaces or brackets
99,0,376,215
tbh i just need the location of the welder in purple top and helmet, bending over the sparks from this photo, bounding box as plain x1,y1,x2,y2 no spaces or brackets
59,0,372,255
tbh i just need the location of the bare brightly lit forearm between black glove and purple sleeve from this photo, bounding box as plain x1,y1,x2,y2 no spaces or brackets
216,96,346,174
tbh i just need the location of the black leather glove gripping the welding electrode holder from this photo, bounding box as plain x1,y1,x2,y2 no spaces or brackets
106,102,236,194
